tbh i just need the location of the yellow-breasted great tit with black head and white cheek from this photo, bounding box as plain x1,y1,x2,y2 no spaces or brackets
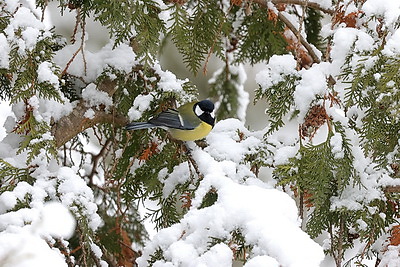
126,100,215,141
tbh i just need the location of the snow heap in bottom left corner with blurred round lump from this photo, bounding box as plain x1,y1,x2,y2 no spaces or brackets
0,201,75,267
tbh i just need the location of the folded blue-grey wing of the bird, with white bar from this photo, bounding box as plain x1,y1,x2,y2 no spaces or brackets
149,109,196,130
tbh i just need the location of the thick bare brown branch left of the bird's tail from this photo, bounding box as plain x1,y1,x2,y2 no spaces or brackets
52,79,128,147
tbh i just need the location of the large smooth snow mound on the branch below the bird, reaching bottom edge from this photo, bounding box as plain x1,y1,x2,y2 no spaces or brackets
138,164,324,267
